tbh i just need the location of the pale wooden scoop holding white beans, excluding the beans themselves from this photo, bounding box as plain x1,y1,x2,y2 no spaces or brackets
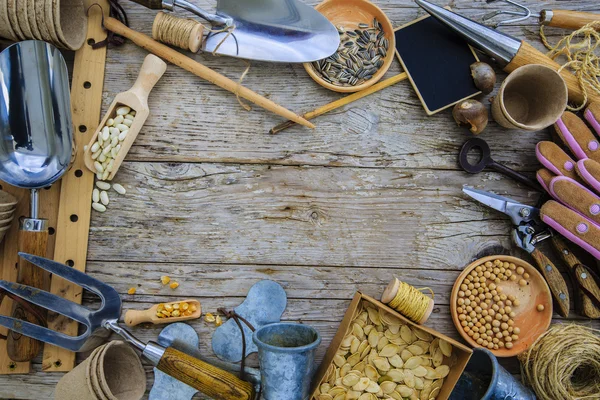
84,54,167,181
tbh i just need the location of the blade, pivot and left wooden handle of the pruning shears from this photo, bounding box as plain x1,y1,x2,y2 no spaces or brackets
463,187,570,317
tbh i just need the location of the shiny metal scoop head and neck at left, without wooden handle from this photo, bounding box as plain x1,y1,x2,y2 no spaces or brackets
0,40,73,219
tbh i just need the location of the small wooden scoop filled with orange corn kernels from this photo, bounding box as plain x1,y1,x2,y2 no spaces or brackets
125,300,202,326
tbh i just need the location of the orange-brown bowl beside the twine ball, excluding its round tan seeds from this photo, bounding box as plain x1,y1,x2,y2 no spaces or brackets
450,256,552,357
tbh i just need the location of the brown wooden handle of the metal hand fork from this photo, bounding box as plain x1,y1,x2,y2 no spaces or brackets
157,347,254,400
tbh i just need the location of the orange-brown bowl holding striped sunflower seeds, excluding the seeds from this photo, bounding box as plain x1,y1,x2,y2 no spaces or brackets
304,0,396,93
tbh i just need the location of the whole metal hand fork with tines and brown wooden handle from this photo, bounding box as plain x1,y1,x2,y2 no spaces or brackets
0,253,254,400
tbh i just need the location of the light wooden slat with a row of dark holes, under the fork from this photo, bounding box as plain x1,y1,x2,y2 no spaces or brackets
42,0,108,372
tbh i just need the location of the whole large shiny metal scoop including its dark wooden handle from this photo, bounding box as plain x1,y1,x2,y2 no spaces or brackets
0,40,73,362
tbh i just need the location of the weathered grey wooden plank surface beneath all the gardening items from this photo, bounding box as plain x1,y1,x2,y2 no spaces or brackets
0,0,600,399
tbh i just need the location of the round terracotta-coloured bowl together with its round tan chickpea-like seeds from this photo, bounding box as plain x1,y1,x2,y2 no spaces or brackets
450,255,552,357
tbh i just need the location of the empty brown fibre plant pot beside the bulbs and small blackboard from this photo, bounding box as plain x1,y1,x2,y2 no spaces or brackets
492,64,568,131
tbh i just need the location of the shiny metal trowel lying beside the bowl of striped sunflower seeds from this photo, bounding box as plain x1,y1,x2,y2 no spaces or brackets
132,0,340,63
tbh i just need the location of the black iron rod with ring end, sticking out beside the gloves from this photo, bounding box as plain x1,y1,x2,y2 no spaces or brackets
458,138,543,192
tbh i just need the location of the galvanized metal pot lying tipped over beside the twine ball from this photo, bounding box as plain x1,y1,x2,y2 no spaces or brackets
450,348,536,400
